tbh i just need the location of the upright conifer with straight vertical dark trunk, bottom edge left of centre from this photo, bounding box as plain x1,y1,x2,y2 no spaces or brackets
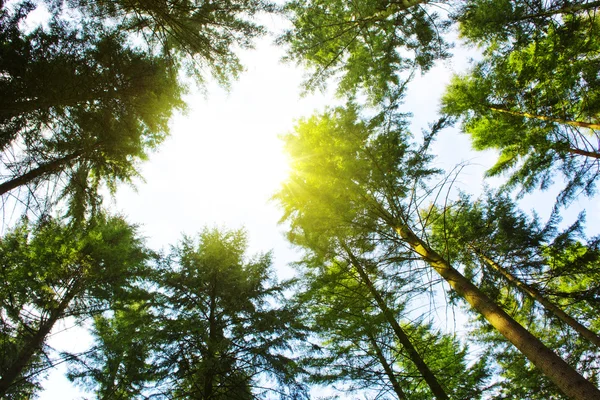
156,229,302,399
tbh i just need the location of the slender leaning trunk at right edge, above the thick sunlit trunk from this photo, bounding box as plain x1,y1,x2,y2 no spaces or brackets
468,246,600,347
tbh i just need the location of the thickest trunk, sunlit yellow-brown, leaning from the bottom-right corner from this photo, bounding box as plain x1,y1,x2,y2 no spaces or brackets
388,223,600,400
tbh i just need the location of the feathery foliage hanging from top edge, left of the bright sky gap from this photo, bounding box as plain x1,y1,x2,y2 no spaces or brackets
68,0,275,86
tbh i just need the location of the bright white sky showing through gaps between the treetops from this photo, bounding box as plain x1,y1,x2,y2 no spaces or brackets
35,9,600,400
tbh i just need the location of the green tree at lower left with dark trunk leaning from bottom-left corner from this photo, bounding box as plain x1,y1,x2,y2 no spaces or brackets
0,215,148,396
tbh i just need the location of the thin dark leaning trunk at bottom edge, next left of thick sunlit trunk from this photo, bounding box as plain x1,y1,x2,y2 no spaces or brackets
342,244,448,400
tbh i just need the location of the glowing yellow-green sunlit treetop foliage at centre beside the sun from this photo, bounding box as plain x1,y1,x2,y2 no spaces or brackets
275,101,437,255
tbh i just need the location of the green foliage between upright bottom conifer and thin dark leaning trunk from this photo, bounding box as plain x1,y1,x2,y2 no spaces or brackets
295,260,408,395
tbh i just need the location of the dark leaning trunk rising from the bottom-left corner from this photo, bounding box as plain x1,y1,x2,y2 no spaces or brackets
0,286,78,399
